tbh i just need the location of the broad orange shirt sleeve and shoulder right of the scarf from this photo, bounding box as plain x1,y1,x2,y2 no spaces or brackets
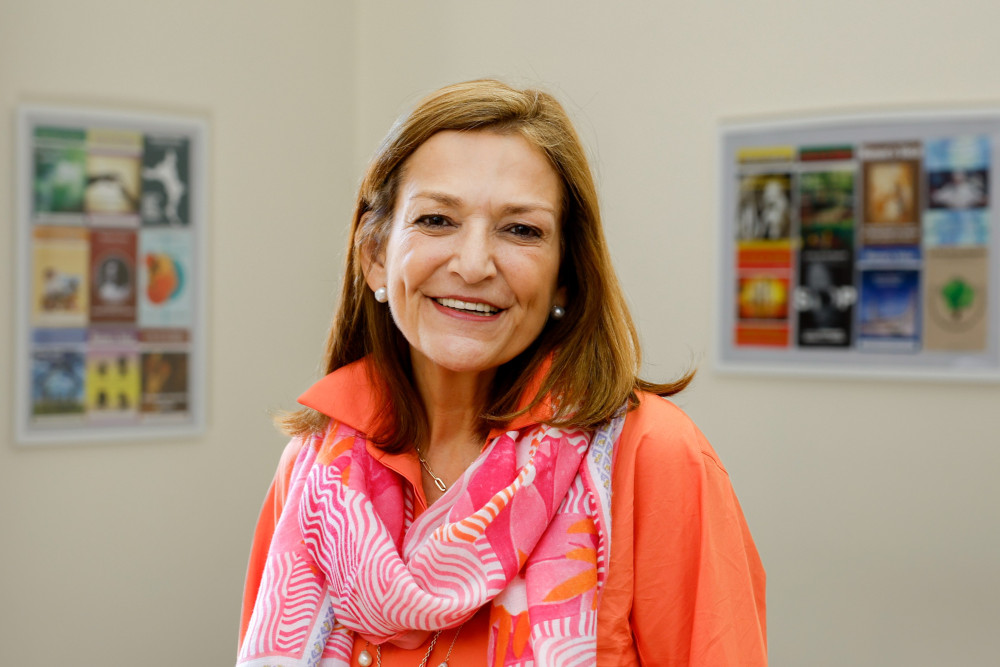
599,396,767,667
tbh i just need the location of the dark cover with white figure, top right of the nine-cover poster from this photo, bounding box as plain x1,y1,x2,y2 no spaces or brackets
141,135,191,225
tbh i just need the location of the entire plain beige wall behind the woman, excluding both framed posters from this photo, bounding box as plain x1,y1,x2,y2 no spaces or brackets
0,0,1000,667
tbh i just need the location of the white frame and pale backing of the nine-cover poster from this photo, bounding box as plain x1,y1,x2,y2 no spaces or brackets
13,104,209,446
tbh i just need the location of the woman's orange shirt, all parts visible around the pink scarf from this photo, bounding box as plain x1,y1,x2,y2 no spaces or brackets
240,363,767,667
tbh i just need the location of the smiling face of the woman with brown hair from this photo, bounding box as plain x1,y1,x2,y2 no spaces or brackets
366,131,565,380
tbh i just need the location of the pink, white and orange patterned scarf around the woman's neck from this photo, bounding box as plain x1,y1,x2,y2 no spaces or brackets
238,415,624,667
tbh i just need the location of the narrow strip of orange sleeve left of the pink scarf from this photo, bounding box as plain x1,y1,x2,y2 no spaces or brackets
237,437,305,647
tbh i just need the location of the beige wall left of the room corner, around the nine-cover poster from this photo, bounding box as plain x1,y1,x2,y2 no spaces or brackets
0,0,356,667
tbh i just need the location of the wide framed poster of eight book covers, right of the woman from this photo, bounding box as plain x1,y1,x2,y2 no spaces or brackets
717,110,1000,381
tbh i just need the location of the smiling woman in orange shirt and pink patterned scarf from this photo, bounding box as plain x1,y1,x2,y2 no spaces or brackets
239,81,766,666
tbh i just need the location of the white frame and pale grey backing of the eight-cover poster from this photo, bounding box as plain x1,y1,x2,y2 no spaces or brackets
714,107,1000,382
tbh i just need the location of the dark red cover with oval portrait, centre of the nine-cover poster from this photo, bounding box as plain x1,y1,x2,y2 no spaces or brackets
90,229,138,322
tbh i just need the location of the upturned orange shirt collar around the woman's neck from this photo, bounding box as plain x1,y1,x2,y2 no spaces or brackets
299,357,554,442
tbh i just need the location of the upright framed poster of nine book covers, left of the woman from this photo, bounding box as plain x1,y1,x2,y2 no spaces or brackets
15,106,207,444
